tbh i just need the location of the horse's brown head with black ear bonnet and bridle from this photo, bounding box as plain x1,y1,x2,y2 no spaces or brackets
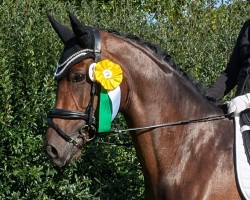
45,14,101,166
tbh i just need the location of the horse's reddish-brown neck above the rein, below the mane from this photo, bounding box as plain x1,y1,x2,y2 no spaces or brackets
101,33,217,126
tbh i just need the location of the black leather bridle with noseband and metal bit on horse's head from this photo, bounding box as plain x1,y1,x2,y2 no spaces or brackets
43,27,101,148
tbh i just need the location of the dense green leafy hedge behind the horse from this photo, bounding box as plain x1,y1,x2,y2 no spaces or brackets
0,0,250,200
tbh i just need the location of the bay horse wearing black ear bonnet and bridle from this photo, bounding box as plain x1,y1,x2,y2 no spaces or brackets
44,14,241,200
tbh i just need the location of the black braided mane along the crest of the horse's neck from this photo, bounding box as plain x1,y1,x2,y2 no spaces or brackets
106,30,205,95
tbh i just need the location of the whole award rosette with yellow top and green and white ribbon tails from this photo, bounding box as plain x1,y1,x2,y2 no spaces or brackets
89,59,123,132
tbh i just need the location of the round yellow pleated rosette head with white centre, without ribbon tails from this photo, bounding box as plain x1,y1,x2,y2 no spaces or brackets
94,59,123,90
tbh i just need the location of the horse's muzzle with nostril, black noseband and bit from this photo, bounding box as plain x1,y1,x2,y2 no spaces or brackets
42,108,96,166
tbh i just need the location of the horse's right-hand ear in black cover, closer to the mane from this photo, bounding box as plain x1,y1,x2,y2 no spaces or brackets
69,12,94,48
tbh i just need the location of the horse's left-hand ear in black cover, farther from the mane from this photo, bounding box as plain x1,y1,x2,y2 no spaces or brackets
47,14,74,44
